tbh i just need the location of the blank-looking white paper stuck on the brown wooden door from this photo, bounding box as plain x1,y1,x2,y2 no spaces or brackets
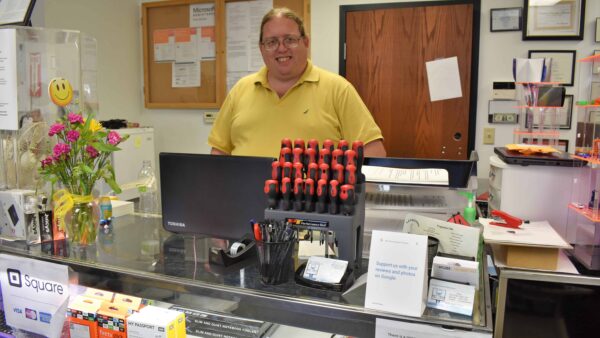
425,56,462,101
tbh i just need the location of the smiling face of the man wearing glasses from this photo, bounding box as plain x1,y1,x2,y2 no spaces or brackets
260,17,308,81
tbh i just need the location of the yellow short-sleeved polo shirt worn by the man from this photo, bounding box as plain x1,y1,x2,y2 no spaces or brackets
208,60,383,158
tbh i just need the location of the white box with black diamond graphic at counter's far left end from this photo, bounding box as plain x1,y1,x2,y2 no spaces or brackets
0,189,35,240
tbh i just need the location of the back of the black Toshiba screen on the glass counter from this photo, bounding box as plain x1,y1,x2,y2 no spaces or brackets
159,153,273,240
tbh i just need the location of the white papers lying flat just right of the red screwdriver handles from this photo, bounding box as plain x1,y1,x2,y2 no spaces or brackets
362,165,448,185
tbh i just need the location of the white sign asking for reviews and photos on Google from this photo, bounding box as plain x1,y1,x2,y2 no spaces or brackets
365,230,427,317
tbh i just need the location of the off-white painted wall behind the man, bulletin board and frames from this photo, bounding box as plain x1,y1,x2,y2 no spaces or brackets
34,0,600,178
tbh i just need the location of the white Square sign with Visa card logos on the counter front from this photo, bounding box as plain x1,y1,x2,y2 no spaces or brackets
0,254,69,337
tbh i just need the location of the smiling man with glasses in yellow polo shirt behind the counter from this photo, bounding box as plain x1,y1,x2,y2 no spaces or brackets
208,8,386,158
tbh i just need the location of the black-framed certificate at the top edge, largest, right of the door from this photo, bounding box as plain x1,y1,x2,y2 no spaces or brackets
523,0,585,40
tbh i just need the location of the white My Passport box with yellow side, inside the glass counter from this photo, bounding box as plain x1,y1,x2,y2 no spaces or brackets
127,306,177,338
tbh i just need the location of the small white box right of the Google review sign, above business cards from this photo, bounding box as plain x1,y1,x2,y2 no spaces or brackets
431,256,479,289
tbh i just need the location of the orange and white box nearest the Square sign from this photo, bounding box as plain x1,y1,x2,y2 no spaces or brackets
67,296,102,338
